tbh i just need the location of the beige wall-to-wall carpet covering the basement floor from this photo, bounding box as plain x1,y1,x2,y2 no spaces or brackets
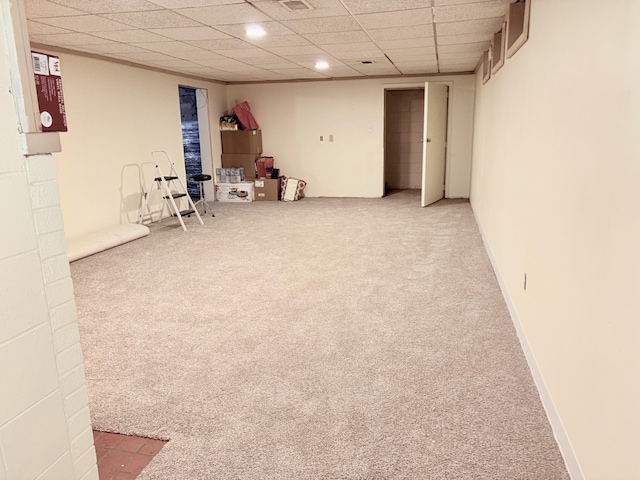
71,192,569,480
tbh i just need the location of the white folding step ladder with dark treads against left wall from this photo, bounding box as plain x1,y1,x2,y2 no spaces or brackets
138,150,204,232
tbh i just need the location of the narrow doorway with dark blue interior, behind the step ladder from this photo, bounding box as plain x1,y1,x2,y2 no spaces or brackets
178,86,213,201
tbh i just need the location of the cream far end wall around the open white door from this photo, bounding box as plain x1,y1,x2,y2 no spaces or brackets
227,75,475,197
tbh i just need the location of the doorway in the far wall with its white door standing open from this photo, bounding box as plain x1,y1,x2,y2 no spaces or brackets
384,82,449,206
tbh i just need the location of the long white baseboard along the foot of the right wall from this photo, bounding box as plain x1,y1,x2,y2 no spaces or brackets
473,212,584,480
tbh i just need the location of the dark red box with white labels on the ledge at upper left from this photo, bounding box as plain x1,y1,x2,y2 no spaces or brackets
31,52,67,132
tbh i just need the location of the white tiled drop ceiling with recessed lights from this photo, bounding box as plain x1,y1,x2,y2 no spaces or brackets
24,0,514,82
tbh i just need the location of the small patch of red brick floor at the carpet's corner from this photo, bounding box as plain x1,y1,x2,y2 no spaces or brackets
93,430,167,480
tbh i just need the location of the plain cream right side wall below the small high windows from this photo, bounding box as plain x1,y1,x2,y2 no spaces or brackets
471,0,640,480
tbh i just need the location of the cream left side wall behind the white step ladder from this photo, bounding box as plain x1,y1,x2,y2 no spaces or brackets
50,53,226,239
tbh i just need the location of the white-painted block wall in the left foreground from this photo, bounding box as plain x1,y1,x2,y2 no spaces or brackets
0,5,98,480
